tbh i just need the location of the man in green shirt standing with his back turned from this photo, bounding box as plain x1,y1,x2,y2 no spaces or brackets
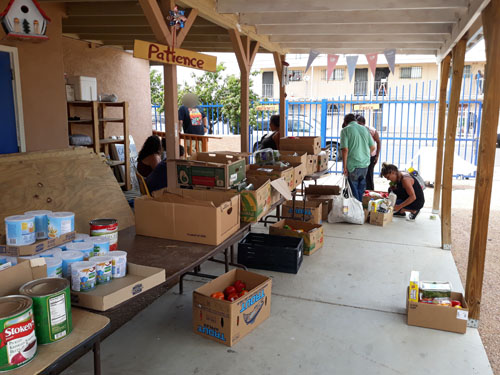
340,113,375,201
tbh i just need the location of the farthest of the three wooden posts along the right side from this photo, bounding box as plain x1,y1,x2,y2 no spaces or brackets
432,54,451,214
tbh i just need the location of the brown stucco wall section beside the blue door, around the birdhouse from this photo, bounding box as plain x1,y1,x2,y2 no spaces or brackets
0,0,68,151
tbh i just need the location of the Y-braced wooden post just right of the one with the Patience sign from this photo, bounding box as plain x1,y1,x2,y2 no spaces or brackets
228,29,259,152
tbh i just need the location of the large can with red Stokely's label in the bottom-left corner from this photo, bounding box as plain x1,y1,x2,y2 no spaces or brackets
0,296,37,371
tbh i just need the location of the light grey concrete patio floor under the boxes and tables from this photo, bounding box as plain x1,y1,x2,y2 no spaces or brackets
64,210,493,375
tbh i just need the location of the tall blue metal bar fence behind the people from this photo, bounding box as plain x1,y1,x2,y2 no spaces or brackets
152,77,482,177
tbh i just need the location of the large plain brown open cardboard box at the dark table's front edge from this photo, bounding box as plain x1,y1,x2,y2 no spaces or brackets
135,189,240,245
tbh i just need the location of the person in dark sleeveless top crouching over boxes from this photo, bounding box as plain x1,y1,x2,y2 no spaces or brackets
381,163,425,221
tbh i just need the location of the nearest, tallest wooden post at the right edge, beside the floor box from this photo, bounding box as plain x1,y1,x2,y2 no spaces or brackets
465,0,500,320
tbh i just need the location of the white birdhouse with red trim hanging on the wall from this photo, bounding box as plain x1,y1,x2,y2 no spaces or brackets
0,0,50,40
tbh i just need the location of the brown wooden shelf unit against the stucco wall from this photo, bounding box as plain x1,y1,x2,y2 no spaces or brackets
68,101,132,190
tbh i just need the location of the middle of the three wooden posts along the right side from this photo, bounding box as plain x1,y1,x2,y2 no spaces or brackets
442,39,467,250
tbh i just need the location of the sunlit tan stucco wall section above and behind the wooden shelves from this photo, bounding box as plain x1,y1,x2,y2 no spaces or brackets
62,37,152,148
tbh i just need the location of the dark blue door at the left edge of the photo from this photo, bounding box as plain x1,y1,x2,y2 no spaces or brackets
0,52,19,154
